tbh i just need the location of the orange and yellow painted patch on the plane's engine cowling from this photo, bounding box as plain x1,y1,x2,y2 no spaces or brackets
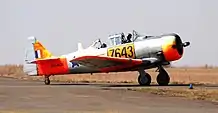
162,39,182,61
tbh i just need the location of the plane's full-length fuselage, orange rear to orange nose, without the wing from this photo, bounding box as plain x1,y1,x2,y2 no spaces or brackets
24,34,187,76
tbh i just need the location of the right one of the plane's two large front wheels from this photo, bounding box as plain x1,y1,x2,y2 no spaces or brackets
157,67,170,86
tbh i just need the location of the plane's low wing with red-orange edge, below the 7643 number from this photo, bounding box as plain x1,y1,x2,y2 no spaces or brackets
71,56,158,72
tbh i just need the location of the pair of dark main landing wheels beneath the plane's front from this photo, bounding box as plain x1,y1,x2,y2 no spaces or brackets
138,66,170,86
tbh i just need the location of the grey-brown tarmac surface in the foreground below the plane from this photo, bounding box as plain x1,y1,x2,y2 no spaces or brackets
0,77,218,113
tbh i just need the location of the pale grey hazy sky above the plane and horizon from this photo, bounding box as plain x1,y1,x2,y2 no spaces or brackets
0,0,218,66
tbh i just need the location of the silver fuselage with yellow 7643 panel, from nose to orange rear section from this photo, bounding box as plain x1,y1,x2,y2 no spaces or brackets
62,34,186,74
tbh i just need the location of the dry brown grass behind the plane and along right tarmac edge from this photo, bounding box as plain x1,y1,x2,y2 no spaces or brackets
0,65,218,102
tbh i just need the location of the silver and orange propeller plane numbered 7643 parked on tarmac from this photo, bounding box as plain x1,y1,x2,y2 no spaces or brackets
23,30,190,86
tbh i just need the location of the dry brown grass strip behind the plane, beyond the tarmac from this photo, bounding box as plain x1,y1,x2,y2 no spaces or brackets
0,65,218,84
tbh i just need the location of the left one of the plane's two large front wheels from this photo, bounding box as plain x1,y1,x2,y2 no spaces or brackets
138,70,151,86
